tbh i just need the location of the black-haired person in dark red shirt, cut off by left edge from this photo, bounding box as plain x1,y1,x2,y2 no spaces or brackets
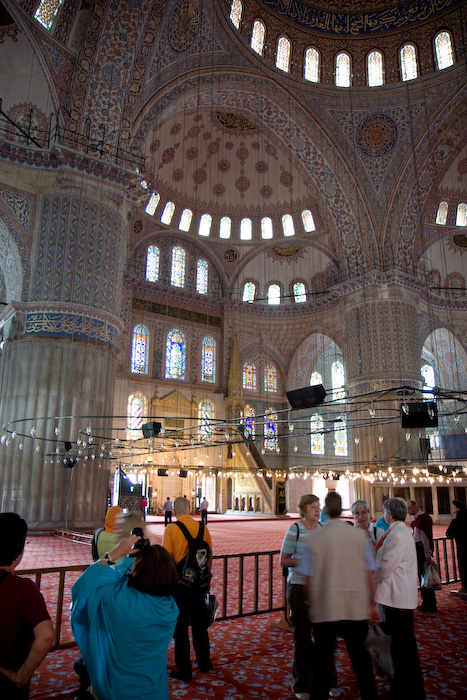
0,513,54,700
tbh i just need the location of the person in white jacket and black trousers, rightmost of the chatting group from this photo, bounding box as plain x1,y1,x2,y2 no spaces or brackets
375,498,425,700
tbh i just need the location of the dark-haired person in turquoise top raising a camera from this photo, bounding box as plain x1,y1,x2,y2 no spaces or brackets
71,528,178,700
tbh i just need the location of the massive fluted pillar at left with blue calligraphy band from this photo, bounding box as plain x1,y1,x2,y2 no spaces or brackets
0,166,126,528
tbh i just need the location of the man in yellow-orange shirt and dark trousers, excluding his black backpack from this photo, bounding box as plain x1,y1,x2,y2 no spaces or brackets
162,496,212,682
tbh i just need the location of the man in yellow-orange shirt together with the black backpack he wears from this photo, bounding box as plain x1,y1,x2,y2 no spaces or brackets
162,497,212,682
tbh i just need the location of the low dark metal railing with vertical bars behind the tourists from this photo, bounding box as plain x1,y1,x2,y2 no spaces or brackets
16,538,459,649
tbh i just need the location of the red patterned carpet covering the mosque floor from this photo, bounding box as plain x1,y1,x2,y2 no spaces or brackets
15,520,467,700
